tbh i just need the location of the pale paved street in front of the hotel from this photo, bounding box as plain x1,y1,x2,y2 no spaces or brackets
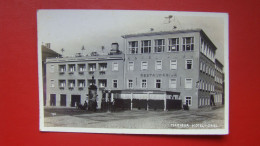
44,107,224,129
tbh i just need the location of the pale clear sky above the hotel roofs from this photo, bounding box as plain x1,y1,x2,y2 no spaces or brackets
37,10,228,63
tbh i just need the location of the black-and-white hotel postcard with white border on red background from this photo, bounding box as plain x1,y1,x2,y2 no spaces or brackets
37,10,229,135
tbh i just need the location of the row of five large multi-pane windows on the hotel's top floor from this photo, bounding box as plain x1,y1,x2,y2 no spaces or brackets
128,37,194,54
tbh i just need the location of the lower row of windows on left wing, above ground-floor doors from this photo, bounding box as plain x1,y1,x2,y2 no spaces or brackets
50,79,118,89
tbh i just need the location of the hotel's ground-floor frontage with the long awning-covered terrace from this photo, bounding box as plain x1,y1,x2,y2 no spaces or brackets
46,89,222,111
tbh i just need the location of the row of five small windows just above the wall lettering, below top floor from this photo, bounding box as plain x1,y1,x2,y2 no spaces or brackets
128,59,193,71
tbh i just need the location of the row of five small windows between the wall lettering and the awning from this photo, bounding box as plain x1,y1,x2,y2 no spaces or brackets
127,78,192,89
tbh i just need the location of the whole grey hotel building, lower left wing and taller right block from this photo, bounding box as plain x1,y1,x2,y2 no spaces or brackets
46,29,224,110
